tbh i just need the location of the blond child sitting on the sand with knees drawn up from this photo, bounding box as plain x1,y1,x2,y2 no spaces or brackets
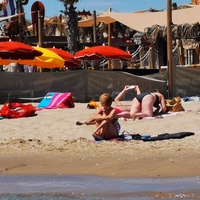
76,93,119,140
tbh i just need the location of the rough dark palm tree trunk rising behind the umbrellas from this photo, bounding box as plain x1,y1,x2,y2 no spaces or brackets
59,0,79,54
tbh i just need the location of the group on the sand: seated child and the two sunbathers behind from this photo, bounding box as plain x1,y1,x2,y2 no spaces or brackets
76,85,167,140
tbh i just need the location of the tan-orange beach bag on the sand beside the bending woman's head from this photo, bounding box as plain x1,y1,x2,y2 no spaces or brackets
166,96,184,112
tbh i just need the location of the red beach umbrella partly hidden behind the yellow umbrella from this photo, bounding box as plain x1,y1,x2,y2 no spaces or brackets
47,47,81,68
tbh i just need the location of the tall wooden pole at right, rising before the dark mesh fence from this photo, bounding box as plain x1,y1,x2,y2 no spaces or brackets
167,0,174,98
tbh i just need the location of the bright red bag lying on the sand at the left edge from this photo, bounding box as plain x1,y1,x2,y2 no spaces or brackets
1,103,36,119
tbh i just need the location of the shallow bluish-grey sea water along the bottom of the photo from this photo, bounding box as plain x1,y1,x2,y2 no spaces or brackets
0,175,200,200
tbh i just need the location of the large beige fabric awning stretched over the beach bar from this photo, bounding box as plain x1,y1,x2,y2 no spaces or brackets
78,5,200,32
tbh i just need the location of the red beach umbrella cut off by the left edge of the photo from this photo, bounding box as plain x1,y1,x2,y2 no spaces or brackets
0,41,42,59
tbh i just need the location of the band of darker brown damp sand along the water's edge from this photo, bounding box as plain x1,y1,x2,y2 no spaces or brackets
0,139,200,178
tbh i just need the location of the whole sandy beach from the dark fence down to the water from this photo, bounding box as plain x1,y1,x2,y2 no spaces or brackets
0,101,200,178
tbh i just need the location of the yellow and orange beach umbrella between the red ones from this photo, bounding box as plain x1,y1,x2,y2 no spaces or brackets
18,47,65,69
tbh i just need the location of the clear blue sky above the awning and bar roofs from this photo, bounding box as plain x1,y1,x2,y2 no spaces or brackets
24,0,192,20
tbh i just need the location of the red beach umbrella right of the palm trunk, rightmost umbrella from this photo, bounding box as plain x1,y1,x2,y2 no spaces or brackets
74,46,132,61
